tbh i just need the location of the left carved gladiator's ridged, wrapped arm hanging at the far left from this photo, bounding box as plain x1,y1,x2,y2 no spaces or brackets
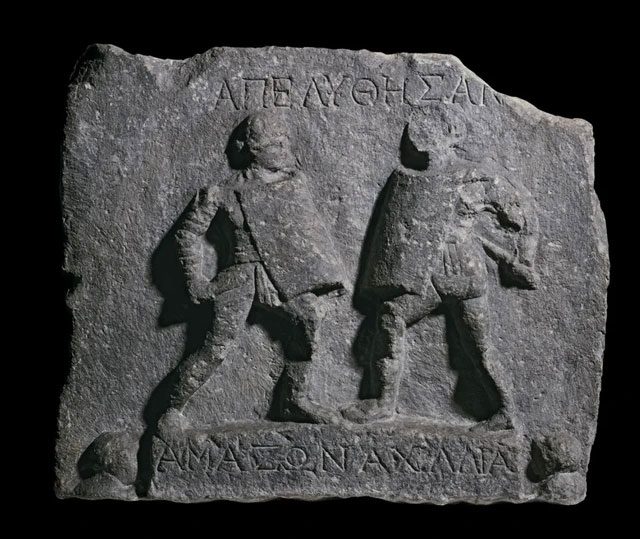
176,188,219,304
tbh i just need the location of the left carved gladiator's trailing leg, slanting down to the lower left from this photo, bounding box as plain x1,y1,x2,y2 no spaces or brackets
158,264,255,430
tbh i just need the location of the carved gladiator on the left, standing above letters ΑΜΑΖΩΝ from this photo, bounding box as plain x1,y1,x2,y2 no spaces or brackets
158,112,345,430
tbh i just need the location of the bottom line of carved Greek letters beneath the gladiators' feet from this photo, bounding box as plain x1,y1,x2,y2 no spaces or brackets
156,439,517,478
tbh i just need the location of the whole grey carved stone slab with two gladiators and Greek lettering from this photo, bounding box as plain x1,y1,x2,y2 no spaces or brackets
57,45,609,504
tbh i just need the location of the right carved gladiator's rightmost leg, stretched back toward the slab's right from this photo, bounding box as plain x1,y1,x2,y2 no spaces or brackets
452,295,513,430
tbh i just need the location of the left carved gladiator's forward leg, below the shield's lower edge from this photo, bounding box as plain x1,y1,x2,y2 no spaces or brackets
278,293,341,423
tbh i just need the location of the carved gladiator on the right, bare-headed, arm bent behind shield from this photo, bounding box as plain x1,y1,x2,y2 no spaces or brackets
342,106,538,430
